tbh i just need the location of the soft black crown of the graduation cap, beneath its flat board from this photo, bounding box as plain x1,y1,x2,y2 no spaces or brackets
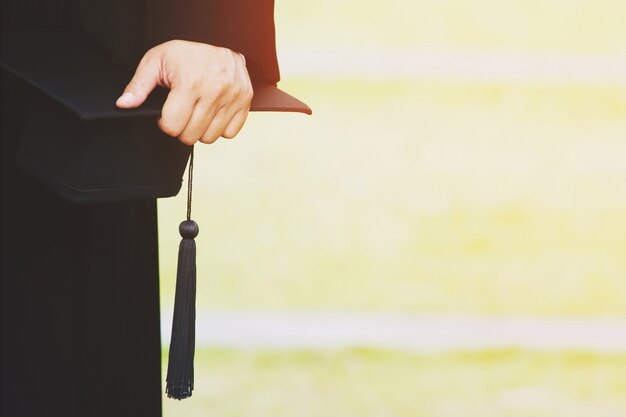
17,76,190,204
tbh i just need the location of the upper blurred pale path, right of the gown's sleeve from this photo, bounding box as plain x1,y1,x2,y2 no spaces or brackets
279,48,626,86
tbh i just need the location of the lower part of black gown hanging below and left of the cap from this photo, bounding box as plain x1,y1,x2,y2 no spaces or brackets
0,70,161,417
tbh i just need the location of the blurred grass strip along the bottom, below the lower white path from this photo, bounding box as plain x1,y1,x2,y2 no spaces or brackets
164,349,626,417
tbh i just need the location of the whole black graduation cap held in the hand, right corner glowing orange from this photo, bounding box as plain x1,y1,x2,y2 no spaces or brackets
2,30,311,203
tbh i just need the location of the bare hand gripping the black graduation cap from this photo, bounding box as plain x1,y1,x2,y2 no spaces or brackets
116,40,253,145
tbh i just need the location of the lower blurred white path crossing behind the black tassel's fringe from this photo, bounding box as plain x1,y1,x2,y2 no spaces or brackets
161,310,626,352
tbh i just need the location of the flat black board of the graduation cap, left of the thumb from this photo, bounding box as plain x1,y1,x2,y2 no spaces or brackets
2,29,167,121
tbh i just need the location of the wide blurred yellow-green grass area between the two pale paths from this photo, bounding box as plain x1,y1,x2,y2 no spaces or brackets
159,79,626,315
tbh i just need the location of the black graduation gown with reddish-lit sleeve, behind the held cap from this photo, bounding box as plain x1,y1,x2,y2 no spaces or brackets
1,0,286,417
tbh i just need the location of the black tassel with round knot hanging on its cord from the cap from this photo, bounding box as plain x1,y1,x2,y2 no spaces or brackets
165,148,199,400
